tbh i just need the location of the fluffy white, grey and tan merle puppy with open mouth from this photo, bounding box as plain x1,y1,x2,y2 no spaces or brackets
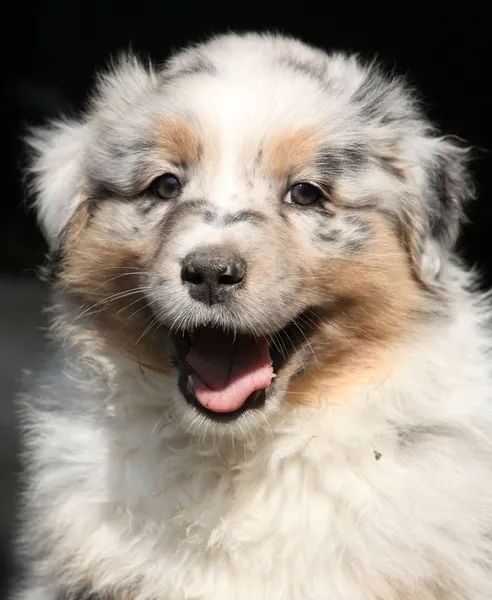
10,34,492,600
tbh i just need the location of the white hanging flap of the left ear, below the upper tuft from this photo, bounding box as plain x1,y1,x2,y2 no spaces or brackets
26,121,89,251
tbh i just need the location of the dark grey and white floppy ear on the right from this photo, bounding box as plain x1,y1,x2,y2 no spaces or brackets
406,137,474,285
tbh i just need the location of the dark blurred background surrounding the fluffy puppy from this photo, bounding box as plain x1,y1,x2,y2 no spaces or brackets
0,0,492,598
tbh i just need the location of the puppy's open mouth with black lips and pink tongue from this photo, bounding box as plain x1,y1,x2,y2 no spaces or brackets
172,315,313,422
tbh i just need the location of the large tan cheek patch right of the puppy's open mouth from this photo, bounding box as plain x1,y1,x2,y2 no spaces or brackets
286,217,425,405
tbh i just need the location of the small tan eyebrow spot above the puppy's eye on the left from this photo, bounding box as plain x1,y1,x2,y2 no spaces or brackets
157,117,200,165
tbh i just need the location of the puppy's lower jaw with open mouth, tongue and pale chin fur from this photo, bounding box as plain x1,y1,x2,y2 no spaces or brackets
170,311,316,426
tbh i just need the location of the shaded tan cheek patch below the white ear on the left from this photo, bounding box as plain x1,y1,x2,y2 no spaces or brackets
55,199,171,374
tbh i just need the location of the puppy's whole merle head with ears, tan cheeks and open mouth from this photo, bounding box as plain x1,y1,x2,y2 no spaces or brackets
31,35,471,431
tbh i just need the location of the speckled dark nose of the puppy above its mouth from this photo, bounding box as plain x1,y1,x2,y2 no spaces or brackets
181,246,246,304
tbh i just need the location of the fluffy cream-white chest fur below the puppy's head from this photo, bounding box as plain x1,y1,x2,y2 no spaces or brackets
21,304,492,600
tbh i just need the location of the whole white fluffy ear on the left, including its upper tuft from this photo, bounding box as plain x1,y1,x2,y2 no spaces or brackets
26,55,156,249
